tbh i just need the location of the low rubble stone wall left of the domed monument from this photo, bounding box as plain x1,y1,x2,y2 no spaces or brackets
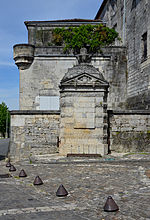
10,111,60,160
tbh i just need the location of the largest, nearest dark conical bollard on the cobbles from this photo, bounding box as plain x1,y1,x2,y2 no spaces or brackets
104,196,119,212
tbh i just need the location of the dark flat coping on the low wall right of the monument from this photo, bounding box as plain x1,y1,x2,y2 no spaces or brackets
108,110,150,115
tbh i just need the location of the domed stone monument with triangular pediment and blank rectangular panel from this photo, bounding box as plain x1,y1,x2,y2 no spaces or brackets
59,64,108,155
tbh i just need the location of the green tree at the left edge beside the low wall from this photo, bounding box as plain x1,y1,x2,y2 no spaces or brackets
0,102,10,137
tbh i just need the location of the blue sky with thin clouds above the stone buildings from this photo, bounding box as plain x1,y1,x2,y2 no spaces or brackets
0,0,102,110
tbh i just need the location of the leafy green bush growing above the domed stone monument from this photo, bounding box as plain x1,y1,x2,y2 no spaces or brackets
53,24,119,53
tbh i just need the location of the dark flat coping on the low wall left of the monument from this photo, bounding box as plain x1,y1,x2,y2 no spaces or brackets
10,110,60,115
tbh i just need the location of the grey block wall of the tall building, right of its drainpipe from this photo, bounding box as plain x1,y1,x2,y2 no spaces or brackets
126,0,150,109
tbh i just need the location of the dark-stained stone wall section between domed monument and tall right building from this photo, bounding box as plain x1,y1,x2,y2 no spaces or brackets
92,46,127,110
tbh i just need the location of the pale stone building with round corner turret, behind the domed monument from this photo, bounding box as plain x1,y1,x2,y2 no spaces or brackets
14,19,126,110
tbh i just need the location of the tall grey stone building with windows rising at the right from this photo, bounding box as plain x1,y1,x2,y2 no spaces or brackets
95,0,150,109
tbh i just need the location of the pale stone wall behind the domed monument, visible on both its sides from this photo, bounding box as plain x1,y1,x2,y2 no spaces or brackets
16,47,127,110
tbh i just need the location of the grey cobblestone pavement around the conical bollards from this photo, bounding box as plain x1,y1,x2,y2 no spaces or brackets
0,158,150,220
